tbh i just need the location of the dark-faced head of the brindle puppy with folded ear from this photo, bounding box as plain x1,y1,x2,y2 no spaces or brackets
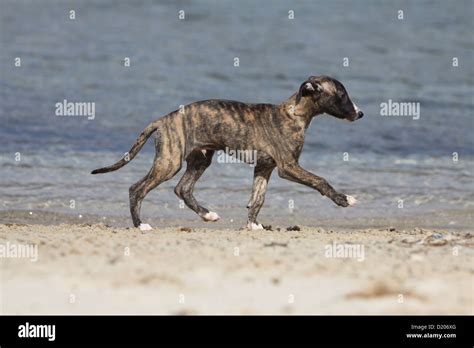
295,76,364,122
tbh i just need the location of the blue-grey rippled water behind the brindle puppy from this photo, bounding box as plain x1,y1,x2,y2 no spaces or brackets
0,0,474,226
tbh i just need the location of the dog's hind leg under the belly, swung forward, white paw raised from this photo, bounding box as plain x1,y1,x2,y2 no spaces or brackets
174,150,219,221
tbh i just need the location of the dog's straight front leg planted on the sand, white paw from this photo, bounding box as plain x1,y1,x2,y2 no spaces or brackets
247,165,275,230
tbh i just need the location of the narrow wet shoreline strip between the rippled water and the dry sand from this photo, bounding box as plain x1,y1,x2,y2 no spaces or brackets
0,209,474,232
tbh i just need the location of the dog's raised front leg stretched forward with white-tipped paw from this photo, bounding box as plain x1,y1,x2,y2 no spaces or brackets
278,164,356,207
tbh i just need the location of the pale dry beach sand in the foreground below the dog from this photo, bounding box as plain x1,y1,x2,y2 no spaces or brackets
0,219,474,314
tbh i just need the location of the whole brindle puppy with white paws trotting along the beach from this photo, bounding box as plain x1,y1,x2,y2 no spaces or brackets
92,76,364,230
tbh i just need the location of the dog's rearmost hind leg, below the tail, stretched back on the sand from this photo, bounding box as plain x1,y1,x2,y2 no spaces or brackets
129,135,182,230
